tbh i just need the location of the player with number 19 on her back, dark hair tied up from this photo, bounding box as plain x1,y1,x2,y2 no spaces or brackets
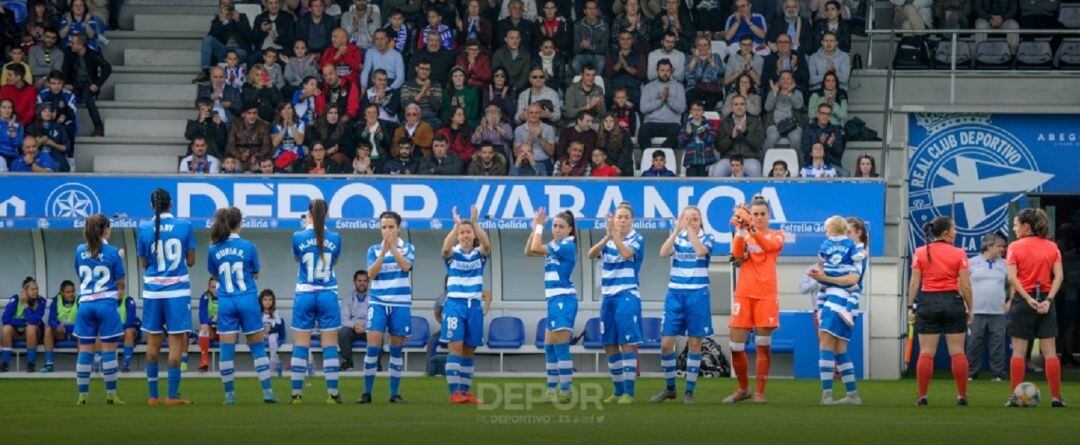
138,189,195,405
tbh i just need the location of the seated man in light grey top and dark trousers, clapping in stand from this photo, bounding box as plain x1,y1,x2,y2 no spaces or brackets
637,59,686,148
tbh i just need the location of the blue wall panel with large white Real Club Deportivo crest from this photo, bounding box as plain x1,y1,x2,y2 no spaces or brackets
907,113,1080,254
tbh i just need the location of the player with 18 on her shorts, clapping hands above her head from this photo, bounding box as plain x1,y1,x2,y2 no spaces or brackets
443,205,491,405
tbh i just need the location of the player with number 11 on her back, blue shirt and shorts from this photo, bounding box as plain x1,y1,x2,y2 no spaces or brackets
206,207,278,405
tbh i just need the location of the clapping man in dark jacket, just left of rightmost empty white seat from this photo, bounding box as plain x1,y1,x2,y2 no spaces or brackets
708,95,768,177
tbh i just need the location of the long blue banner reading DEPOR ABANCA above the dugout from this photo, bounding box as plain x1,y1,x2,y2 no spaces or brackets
0,175,885,256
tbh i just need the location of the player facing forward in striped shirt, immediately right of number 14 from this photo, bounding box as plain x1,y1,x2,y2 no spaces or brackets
356,212,416,403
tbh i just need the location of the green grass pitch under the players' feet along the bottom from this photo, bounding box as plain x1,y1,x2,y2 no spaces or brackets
0,375,1080,445
